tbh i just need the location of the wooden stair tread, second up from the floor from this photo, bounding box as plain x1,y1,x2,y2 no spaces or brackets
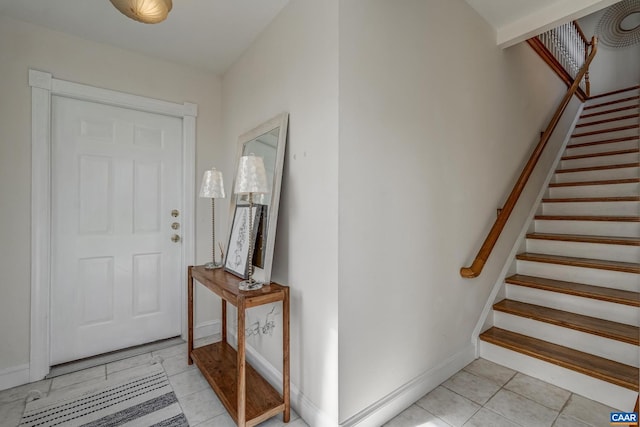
493,299,640,345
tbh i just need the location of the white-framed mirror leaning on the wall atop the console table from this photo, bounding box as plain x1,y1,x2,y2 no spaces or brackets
225,113,289,284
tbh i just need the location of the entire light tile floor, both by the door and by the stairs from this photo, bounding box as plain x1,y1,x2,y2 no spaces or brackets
0,342,613,427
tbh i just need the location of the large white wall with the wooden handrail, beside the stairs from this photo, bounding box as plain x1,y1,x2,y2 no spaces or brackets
339,0,566,424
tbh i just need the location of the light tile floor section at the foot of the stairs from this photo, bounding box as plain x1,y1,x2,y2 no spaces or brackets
385,359,614,427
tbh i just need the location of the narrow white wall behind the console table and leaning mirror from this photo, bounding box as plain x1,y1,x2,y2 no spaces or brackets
222,0,338,426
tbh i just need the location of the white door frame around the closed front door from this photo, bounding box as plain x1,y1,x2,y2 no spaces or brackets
29,69,198,381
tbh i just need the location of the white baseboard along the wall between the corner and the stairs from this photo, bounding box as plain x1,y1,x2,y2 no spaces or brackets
340,342,476,427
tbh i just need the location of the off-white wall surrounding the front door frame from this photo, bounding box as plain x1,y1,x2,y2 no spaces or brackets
0,16,222,385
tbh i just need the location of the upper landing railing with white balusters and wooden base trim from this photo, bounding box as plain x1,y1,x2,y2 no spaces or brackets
527,21,591,101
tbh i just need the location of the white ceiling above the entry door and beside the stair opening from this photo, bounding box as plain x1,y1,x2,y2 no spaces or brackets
0,0,619,74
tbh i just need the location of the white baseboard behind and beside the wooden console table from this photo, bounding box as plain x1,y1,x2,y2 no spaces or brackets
227,330,338,427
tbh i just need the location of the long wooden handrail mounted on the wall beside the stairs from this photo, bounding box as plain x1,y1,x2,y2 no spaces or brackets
460,36,598,278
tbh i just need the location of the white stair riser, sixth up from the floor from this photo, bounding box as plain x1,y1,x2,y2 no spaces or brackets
535,220,640,237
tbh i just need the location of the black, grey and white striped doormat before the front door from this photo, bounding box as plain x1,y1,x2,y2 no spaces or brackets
19,363,189,427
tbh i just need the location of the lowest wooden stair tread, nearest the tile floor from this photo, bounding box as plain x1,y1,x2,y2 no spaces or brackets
480,327,638,391
